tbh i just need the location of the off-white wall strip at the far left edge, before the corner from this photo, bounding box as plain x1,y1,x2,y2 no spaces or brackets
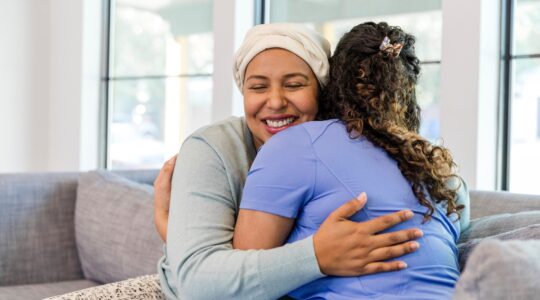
0,0,50,172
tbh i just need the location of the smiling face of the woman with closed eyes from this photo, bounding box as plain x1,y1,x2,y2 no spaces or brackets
243,48,319,148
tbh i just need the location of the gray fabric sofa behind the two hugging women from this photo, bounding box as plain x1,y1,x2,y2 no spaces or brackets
0,170,540,300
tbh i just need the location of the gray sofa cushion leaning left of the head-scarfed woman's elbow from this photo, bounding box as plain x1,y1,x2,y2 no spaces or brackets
75,171,162,283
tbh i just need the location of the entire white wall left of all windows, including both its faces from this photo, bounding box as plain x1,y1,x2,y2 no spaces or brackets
0,0,101,173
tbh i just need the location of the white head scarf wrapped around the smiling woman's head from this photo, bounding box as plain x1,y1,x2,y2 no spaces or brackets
233,23,330,92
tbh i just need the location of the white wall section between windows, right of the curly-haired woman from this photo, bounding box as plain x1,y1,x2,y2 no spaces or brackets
440,0,500,190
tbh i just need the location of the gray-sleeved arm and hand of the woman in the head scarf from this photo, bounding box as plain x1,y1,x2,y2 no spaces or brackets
158,133,419,299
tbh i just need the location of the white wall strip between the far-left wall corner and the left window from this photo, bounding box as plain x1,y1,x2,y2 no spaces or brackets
48,0,102,171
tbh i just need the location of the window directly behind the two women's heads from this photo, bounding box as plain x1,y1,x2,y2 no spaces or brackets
260,0,442,141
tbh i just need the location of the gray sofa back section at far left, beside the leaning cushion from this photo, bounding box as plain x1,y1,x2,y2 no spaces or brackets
0,173,82,286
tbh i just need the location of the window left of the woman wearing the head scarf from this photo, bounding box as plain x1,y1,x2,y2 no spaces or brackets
104,0,213,169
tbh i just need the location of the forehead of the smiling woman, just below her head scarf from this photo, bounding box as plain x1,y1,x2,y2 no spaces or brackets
245,48,315,77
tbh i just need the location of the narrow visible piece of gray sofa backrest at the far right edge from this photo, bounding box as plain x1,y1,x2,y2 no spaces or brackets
470,190,540,220
